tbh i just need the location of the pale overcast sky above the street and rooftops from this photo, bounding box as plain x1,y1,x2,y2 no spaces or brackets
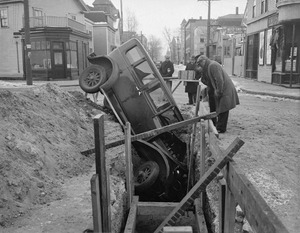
84,0,247,52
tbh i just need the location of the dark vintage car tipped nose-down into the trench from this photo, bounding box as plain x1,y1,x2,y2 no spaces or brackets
79,39,187,201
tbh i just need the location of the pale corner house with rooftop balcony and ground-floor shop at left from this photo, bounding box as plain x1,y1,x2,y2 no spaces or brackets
0,0,91,80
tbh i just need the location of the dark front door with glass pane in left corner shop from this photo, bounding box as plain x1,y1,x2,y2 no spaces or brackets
52,42,66,79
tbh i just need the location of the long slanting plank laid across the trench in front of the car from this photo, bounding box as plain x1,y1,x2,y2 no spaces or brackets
81,112,217,155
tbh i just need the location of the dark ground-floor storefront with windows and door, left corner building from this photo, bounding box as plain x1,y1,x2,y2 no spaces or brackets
19,28,90,81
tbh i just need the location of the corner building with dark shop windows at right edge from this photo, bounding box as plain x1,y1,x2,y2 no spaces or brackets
245,0,300,86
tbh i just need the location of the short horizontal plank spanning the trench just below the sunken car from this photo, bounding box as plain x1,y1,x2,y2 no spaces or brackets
138,202,178,216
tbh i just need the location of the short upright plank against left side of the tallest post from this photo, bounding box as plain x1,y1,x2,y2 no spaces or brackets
91,174,102,232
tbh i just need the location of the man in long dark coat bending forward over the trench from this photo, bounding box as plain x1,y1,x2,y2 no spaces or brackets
197,55,240,133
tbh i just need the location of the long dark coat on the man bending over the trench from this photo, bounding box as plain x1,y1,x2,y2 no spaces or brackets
203,60,240,113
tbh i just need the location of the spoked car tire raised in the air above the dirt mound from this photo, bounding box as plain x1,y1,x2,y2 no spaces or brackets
79,65,107,93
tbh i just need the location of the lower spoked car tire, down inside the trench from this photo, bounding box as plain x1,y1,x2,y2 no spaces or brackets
134,161,159,192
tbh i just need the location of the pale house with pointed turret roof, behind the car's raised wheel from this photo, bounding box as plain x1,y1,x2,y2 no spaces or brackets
84,0,121,55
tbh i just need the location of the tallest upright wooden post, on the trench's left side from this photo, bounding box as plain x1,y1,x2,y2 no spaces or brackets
93,114,111,232
